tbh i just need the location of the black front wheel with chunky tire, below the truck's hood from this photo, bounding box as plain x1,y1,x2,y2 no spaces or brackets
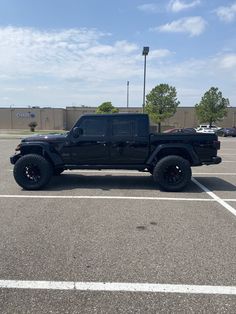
13,154,52,190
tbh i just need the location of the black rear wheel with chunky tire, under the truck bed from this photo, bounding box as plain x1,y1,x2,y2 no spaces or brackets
153,155,192,192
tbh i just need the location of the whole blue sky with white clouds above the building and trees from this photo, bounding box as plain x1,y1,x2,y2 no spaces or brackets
0,0,236,107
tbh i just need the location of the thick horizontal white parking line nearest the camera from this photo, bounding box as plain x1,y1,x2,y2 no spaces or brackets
0,280,236,295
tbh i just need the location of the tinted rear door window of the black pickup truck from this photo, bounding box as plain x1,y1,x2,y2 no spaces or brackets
112,118,135,136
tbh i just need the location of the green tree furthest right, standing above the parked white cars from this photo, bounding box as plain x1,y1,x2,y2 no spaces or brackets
195,87,229,127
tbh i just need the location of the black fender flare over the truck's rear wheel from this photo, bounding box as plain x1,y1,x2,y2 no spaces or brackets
146,143,201,166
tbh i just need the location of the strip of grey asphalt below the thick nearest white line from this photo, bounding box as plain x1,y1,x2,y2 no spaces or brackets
0,289,236,314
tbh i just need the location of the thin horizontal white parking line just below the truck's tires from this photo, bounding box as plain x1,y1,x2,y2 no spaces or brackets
0,194,215,202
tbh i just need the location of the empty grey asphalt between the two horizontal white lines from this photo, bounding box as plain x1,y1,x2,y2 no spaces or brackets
1,199,236,285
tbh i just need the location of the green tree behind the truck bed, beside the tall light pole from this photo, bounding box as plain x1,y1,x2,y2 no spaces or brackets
145,84,180,132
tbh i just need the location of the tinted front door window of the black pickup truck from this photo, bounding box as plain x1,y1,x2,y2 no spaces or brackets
79,117,107,136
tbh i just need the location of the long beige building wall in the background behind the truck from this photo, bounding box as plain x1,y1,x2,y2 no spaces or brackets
0,107,236,130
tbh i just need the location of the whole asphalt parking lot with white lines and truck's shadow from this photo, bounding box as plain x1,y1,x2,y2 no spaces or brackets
0,138,236,313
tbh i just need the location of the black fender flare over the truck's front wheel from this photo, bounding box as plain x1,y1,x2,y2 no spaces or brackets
20,141,64,166
